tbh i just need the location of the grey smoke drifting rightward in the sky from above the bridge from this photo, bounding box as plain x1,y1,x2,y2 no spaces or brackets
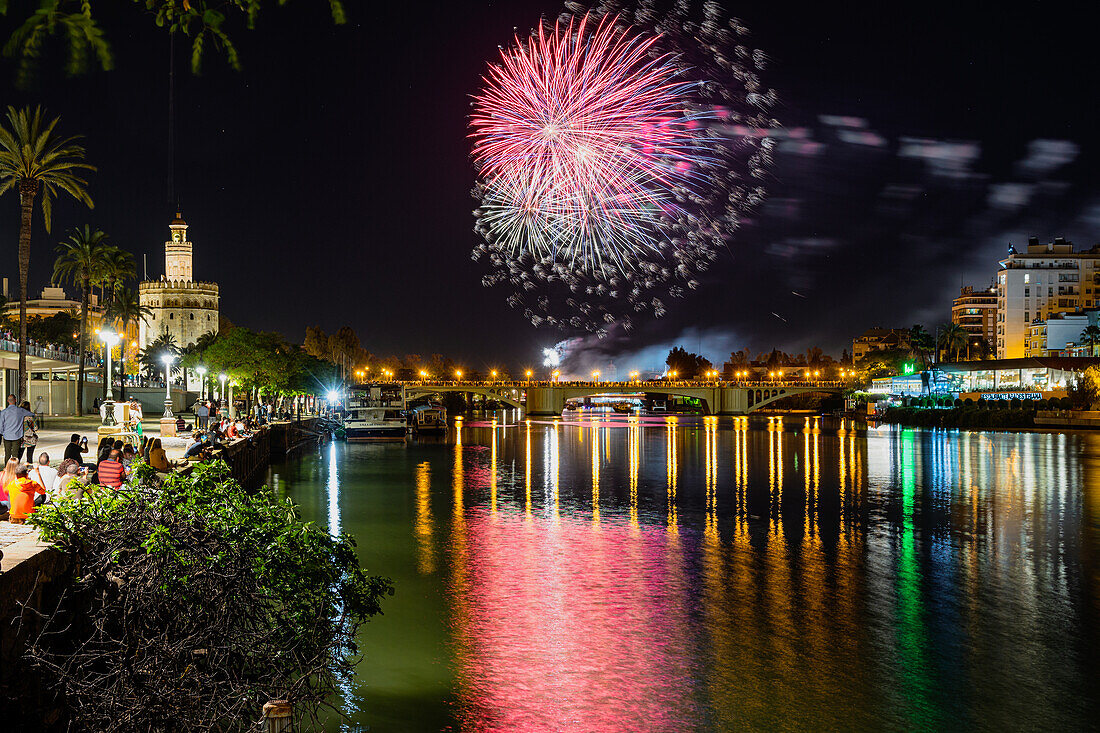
562,116,1100,374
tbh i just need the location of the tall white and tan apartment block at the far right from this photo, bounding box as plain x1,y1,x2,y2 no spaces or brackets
997,237,1100,359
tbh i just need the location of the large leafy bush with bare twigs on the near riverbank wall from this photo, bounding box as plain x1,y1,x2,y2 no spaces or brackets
28,462,393,731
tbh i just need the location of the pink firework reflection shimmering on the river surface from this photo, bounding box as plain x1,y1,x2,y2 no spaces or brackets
453,507,697,732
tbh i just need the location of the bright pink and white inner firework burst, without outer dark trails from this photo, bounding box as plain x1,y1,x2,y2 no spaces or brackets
471,17,704,272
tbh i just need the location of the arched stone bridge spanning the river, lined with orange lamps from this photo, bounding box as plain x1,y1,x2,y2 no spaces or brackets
403,380,844,415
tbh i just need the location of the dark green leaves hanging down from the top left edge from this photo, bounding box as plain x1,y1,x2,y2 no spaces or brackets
0,0,347,87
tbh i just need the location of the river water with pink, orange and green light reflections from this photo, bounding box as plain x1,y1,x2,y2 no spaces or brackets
268,415,1100,732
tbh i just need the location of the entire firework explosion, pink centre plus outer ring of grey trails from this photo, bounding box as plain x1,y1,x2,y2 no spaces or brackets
471,3,776,333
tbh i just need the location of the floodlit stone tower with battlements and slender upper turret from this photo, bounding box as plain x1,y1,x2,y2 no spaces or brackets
139,214,219,349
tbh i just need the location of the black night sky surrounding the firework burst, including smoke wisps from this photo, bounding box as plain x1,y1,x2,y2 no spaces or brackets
0,0,1100,368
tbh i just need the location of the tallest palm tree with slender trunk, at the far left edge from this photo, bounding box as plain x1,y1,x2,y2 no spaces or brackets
0,107,96,400
